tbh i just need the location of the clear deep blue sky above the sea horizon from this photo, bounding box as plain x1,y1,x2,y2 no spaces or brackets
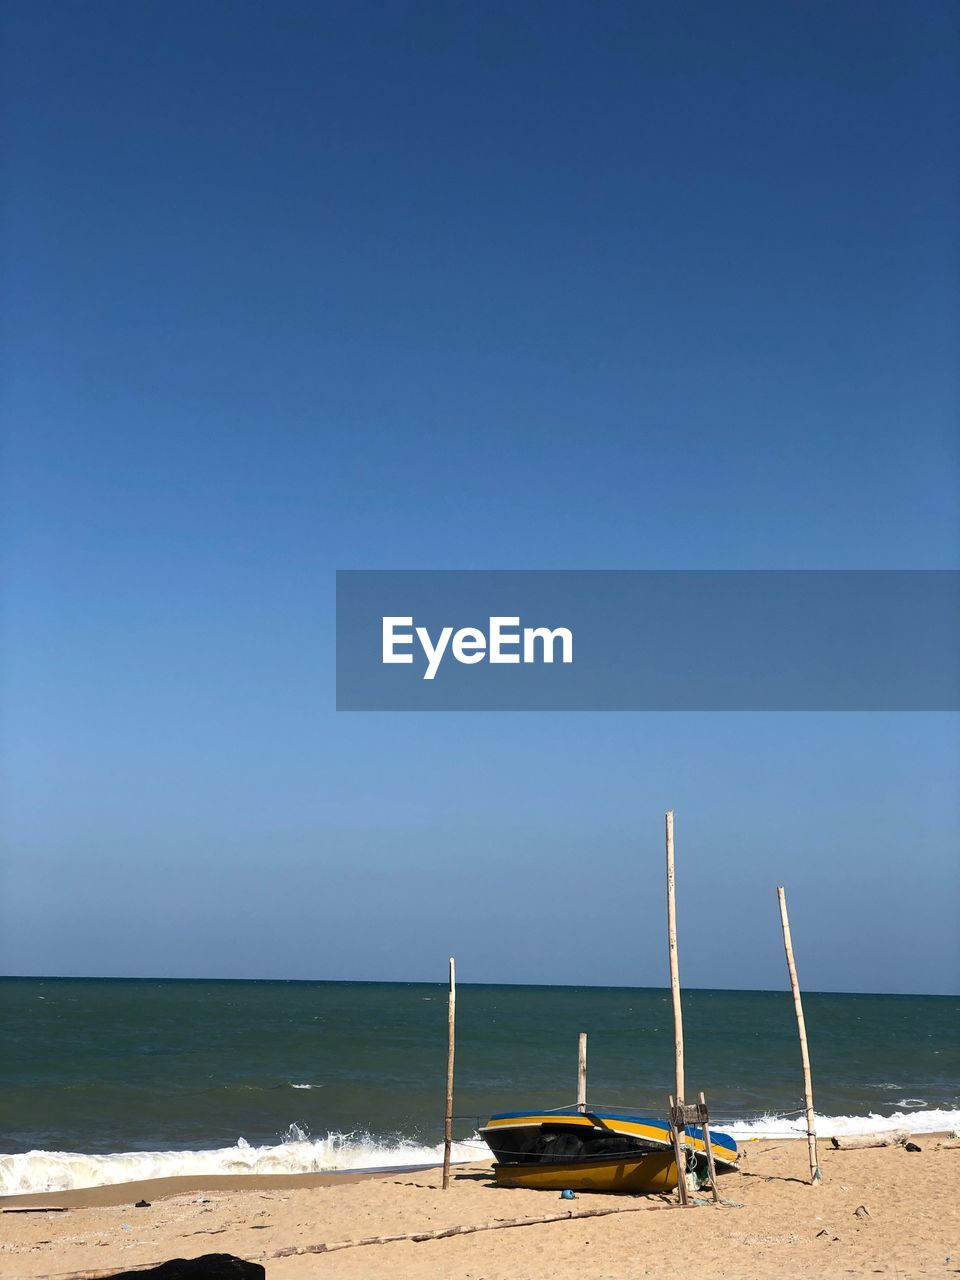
0,0,960,992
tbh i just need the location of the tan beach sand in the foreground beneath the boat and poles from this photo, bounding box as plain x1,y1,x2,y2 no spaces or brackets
0,1134,960,1280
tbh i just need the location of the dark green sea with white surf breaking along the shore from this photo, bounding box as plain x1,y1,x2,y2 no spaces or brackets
0,978,960,1194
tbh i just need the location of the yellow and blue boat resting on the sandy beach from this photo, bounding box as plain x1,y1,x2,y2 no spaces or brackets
480,1107,740,1192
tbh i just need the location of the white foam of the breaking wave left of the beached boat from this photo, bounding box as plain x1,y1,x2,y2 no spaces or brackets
0,1125,486,1196
